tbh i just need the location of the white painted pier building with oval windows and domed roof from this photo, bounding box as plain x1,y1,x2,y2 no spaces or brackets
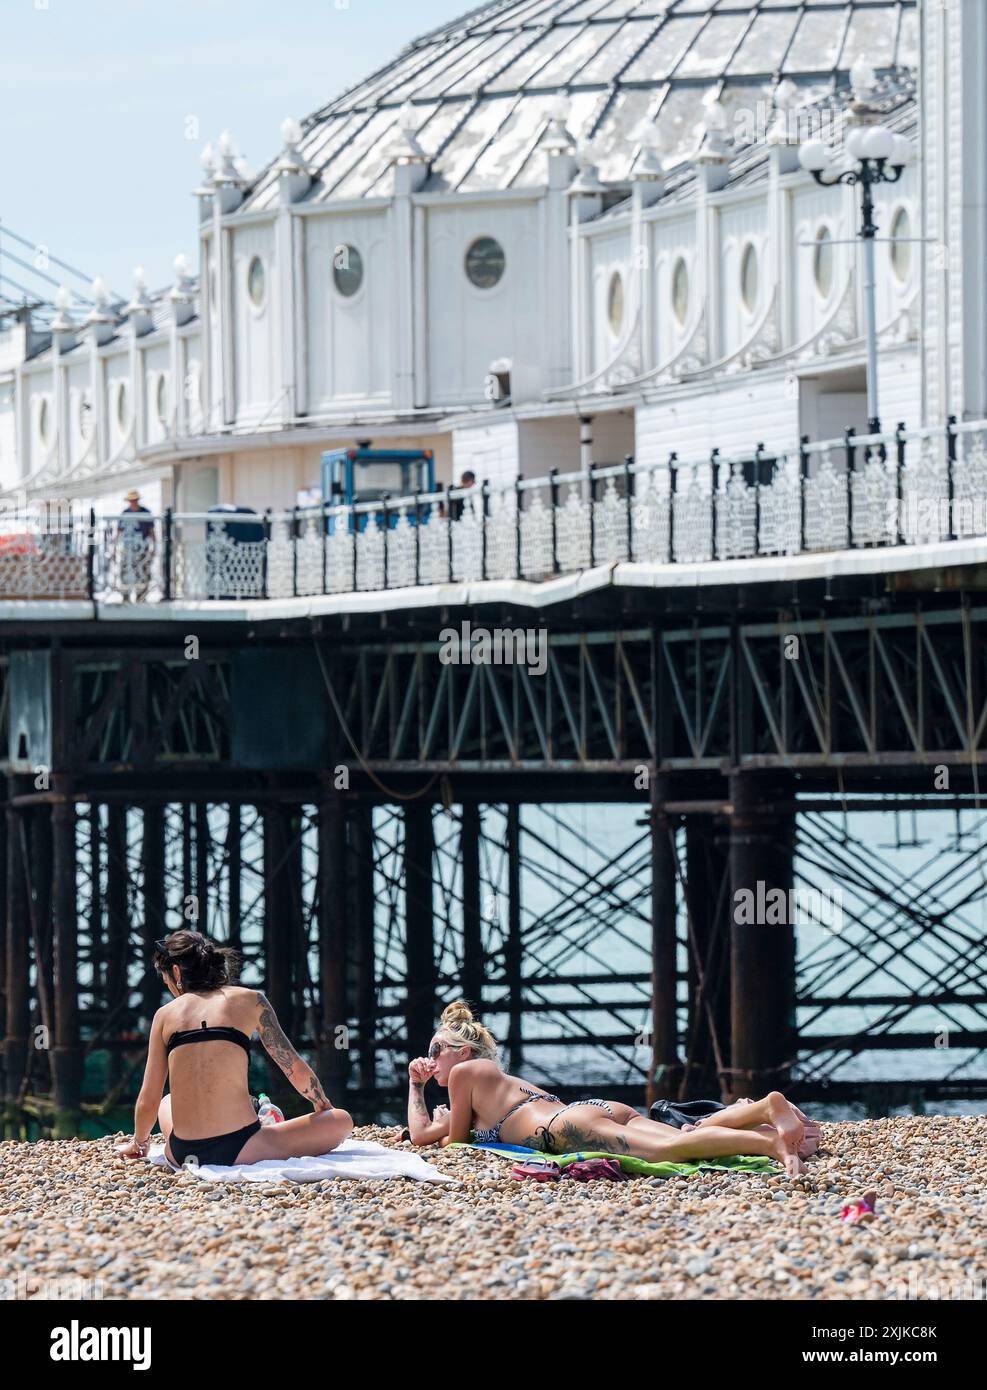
0,0,956,522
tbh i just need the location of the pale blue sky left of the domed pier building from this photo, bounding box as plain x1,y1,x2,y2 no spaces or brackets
0,0,464,299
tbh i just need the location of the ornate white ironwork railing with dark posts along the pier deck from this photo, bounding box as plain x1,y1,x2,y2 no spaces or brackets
0,420,987,602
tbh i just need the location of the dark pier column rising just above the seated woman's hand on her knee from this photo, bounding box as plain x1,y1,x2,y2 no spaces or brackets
318,794,349,1104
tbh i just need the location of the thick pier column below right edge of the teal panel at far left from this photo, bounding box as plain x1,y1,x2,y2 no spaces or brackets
51,778,82,1138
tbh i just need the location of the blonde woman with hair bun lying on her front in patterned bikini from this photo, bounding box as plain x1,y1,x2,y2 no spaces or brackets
407,999,819,1177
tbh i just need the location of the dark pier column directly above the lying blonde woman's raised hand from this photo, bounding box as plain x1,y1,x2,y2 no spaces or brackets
405,801,435,1059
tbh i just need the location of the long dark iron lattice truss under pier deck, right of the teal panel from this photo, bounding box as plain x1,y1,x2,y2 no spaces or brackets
316,603,987,774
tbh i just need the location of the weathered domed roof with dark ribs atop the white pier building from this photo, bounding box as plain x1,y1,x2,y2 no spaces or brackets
245,0,917,209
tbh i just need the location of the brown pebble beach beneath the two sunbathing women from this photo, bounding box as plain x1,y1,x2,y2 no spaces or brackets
0,1116,987,1300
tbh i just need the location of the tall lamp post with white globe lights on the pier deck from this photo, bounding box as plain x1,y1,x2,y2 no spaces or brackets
798,58,912,434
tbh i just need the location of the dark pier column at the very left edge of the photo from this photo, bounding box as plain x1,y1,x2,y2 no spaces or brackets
3,777,31,1138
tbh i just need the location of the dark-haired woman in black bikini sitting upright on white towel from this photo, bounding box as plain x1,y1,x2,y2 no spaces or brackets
117,931,353,1168
